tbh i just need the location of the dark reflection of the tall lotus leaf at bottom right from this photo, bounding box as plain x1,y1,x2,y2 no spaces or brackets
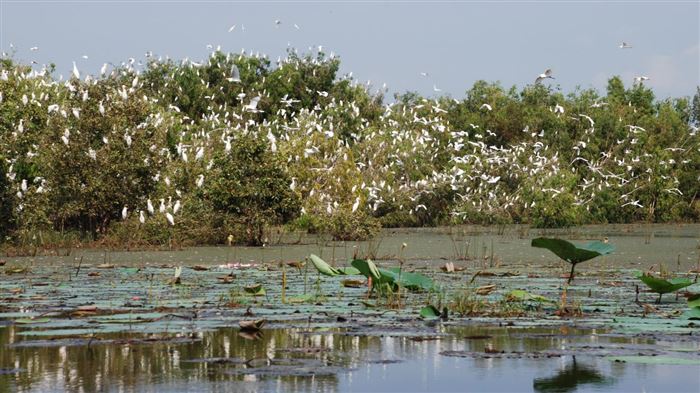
532,356,613,393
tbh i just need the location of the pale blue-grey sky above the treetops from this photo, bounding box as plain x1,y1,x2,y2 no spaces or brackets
0,0,700,99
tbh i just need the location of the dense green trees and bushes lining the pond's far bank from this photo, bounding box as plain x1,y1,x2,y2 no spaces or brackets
0,52,700,244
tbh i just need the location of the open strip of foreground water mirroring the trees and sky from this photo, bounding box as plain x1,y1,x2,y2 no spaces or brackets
0,326,700,392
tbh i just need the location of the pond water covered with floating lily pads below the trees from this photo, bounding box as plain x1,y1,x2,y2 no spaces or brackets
0,224,700,393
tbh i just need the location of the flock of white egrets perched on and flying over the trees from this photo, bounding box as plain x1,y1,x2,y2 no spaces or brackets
0,31,698,230
